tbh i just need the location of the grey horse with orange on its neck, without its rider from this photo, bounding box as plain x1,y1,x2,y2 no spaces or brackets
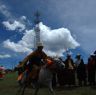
18,58,64,95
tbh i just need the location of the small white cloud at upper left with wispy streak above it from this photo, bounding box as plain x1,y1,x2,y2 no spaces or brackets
0,3,27,32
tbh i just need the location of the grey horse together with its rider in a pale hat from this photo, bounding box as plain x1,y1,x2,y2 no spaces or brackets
17,43,62,95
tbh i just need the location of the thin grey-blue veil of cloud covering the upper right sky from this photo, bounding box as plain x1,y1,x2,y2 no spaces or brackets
47,0,96,54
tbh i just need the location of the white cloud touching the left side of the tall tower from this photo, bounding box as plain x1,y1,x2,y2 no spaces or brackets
3,30,34,53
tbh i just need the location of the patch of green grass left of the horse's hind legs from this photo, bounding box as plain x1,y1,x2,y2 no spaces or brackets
0,73,18,95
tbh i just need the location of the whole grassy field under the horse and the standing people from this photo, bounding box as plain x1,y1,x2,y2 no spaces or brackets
0,72,96,95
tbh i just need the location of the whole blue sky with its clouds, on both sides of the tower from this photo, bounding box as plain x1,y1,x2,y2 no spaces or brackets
0,0,96,68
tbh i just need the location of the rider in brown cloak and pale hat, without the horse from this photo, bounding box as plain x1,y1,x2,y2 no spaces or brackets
22,42,47,80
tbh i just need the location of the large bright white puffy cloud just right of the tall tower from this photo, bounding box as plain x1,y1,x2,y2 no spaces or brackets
40,23,80,55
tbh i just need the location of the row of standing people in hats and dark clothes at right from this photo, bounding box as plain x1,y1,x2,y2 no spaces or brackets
53,53,96,86
